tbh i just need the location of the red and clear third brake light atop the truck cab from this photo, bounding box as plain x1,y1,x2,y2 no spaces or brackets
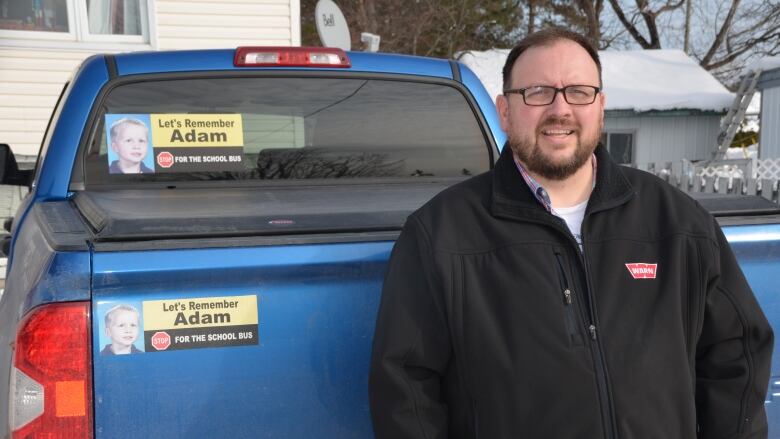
233,47,352,68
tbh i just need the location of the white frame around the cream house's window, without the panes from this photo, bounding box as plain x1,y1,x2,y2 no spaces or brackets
0,0,156,50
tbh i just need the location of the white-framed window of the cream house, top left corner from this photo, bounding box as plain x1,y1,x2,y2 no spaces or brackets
0,0,152,44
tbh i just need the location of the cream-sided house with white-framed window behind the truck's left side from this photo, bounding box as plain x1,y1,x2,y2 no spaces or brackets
0,0,301,161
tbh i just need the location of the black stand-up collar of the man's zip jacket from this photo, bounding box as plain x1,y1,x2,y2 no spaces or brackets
491,144,634,219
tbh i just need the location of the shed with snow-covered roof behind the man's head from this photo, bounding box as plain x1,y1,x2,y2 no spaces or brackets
460,49,734,164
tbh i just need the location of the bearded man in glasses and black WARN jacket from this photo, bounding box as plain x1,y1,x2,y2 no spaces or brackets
369,29,772,439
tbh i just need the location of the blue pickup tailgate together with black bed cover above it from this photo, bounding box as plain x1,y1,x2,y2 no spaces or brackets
83,181,446,439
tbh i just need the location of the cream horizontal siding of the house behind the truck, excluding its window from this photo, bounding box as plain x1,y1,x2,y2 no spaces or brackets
0,0,301,159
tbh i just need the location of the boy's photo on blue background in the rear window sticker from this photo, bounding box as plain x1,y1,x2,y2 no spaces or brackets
106,115,154,174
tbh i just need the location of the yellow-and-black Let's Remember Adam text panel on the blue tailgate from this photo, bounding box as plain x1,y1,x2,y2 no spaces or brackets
143,295,258,352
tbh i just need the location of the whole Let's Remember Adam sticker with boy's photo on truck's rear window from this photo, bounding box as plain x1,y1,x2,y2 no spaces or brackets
106,114,245,174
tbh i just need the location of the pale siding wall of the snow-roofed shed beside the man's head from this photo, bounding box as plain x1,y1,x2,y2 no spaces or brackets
604,115,720,164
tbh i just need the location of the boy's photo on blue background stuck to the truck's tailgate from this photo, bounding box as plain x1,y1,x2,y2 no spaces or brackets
97,302,144,356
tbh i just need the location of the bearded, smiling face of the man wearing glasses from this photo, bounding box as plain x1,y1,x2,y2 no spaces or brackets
496,40,604,180
